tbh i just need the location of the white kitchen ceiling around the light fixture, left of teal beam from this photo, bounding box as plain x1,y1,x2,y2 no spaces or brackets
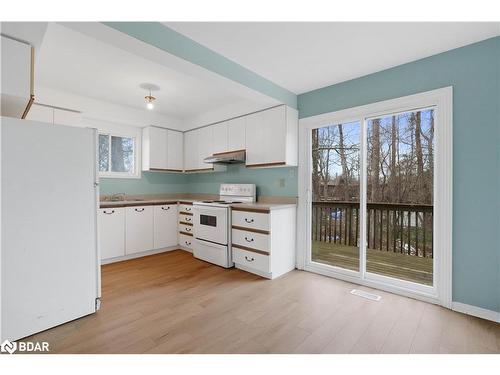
35,23,258,118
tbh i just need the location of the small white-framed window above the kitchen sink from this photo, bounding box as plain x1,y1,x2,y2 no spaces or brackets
99,133,138,178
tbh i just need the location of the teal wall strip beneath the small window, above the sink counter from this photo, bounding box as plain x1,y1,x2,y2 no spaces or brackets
99,172,188,195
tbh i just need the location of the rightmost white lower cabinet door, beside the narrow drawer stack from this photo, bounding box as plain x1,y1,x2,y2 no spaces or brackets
153,204,177,249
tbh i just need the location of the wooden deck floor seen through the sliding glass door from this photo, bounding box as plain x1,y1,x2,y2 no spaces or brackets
312,241,432,285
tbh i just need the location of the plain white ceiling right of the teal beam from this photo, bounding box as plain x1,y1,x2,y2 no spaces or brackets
165,22,500,94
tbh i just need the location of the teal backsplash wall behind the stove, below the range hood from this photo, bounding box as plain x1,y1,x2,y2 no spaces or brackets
188,165,297,197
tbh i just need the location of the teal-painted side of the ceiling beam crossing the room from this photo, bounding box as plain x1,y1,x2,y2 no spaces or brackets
103,22,297,108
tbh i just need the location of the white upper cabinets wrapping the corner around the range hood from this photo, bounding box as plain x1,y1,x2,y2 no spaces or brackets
142,105,298,172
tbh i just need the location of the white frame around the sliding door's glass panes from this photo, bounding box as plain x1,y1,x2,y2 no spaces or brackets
297,86,453,308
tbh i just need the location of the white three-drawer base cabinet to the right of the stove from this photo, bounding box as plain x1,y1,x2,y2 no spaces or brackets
231,205,296,279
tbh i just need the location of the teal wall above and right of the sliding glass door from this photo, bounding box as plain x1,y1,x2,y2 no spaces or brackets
298,37,500,311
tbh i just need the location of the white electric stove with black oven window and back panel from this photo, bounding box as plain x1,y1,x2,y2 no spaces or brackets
193,184,256,268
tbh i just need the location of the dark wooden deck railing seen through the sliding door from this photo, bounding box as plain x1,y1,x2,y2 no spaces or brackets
312,201,433,258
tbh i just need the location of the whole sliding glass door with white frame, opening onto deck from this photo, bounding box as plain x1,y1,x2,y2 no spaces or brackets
299,89,451,305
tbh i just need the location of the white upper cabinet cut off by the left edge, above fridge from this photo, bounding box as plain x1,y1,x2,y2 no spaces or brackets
0,35,34,118
